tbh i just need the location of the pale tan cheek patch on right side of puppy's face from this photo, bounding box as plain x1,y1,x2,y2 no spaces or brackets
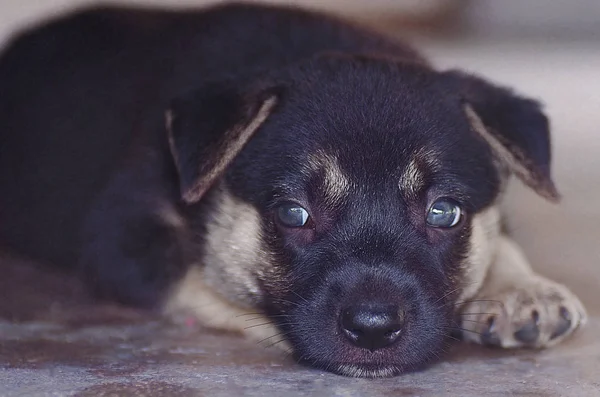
458,204,500,301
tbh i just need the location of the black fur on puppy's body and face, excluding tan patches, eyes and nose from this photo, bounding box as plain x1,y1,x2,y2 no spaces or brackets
0,5,551,376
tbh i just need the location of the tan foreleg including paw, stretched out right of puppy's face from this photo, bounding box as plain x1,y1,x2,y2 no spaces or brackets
460,235,586,348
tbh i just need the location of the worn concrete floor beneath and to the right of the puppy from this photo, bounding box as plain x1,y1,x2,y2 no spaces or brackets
0,7,600,397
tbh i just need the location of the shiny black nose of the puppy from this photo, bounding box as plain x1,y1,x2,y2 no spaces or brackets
341,304,404,351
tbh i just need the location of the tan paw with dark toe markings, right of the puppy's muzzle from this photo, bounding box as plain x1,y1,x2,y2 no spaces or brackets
460,276,587,348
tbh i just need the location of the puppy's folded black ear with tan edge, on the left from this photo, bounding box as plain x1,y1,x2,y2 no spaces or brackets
167,82,277,204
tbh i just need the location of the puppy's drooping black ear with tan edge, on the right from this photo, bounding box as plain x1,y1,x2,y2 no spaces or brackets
445,71,560,201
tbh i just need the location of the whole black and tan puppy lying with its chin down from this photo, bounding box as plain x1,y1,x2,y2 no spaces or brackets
0,1,585,377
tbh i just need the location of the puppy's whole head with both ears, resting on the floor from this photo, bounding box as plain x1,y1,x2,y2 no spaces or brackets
169,56,557,377
